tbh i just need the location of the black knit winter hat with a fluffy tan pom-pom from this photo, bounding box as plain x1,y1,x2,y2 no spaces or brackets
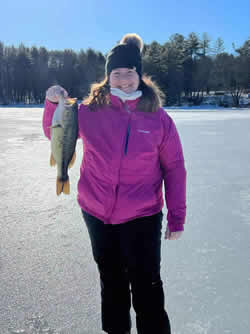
105,34,143,77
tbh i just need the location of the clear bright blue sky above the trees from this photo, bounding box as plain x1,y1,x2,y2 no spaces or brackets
0,0,250,53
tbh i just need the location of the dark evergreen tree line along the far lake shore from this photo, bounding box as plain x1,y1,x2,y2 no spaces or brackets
0,33,250,106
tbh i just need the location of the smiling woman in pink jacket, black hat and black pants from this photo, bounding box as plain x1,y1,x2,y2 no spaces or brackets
43,34,186,334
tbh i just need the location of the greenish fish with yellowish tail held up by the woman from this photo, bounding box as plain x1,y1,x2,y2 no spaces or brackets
50,94,78,196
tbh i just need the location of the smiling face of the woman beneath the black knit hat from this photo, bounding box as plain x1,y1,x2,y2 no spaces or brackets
109,67,139,94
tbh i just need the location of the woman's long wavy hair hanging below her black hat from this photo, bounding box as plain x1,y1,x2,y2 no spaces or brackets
82,75,164,112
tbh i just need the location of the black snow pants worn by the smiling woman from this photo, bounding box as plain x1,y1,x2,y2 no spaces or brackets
82,211,171,334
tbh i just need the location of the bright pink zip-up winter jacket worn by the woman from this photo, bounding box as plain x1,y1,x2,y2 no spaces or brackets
43,95,186,232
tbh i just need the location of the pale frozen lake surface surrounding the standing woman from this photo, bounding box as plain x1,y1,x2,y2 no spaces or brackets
0,108,250,334
